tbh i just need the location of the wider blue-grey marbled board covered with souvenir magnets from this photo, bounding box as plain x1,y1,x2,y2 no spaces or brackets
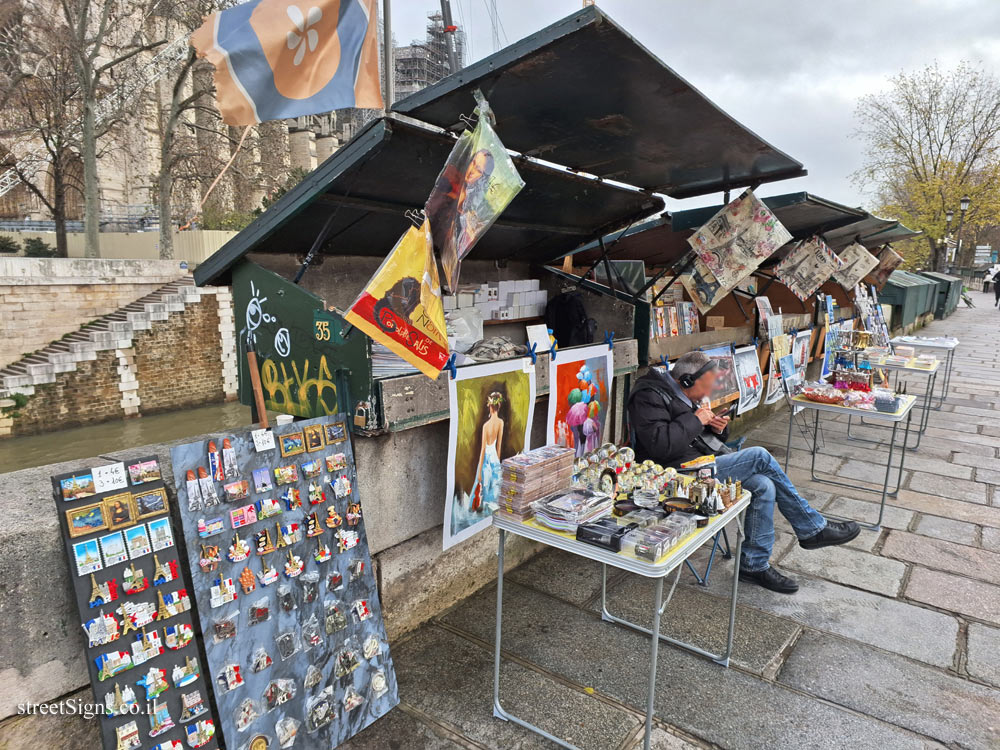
171,414,399,750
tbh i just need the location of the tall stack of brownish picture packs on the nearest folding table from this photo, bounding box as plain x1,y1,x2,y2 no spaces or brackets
497,445,574,521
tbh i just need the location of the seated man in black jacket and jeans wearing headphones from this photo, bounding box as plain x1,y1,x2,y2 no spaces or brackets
628,352,860,594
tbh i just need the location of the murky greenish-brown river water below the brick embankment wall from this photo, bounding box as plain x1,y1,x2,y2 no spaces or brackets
0,402,250,474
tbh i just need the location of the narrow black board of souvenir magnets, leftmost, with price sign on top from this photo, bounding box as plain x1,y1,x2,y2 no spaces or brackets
52,456,218,750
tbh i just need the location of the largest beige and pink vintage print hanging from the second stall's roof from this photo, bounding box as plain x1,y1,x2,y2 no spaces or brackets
688,190,792,289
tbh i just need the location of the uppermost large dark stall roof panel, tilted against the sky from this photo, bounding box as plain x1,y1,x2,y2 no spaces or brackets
393,6,806,198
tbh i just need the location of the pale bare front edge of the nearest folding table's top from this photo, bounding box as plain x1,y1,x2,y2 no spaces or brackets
493,490,750,578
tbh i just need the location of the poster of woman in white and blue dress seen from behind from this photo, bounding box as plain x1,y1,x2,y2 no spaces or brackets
443,357,535,549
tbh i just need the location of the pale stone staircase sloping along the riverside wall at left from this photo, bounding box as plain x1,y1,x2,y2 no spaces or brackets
0,277,207,406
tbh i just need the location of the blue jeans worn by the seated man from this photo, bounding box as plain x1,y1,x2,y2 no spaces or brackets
715,447,826,571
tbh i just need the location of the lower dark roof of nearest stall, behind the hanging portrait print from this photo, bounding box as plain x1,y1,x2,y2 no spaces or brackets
195,115,663,285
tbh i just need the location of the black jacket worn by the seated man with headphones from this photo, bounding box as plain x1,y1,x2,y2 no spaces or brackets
627,369,729,467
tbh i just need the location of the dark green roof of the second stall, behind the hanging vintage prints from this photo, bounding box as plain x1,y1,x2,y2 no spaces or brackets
573,193,868,265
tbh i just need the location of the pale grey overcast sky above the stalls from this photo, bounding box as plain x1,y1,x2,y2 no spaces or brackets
392,0,1000,214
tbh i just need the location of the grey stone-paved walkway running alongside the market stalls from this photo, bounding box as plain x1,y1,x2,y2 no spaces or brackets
347,292,1000,750
